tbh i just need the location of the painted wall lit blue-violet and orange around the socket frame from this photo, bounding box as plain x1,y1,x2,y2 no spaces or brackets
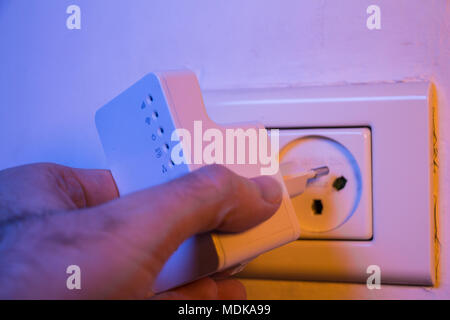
0,0,450,299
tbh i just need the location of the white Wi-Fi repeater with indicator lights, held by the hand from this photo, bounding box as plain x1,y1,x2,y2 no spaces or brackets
95,71,300,292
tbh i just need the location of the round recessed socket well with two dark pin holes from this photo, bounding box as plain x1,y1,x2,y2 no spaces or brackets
280,135,362,234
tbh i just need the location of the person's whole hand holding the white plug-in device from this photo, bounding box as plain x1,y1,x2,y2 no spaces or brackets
0,163,282,299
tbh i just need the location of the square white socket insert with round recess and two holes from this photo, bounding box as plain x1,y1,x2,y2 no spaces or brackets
280,128,372,240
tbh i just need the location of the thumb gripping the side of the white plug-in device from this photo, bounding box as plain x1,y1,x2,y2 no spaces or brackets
88,165,282,276
